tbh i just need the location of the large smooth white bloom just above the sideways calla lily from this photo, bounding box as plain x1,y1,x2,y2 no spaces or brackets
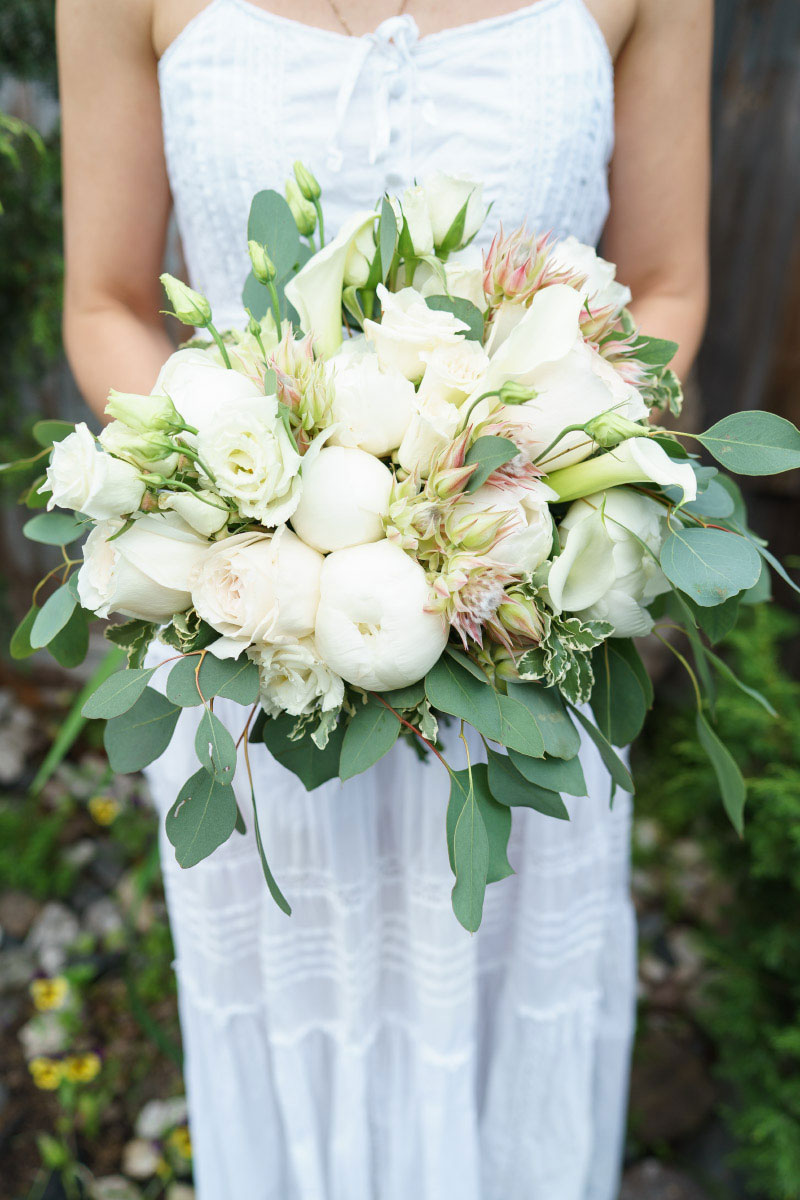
497,340,648,470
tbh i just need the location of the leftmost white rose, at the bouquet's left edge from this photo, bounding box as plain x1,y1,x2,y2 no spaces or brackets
40,421,145,521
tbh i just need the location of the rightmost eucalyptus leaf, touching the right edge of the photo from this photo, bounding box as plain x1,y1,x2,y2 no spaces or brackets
698,409,800,475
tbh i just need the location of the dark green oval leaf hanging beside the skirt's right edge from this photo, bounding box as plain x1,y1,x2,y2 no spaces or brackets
591,637,652,746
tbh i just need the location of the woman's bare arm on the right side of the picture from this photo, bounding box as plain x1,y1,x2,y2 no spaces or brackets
603,0,712,377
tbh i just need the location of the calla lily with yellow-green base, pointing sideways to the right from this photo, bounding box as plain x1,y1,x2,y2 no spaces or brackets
547,438,697,504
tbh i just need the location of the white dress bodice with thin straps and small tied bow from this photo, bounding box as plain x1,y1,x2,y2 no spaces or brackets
160,0,613,325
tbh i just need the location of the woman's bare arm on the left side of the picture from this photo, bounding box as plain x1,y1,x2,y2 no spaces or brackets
56,0,172,414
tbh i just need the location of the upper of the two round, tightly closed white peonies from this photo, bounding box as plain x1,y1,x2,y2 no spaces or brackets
291,446,392,552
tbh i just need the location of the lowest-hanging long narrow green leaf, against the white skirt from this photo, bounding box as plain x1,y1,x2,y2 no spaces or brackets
447,763,489,934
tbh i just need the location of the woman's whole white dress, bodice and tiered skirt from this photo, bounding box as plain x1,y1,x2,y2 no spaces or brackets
148,0,634,1200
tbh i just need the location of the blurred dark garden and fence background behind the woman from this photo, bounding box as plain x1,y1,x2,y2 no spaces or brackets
0,0,800,1200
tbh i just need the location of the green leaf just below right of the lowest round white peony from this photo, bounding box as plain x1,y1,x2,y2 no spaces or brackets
425,654,545,756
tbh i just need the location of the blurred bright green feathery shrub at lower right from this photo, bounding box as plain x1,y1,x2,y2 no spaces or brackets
637,606,800,1200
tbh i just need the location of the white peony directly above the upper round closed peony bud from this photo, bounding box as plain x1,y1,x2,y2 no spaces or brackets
327,352,414,457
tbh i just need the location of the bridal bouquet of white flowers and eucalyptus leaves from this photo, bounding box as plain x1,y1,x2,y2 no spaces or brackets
12,163,800,930
